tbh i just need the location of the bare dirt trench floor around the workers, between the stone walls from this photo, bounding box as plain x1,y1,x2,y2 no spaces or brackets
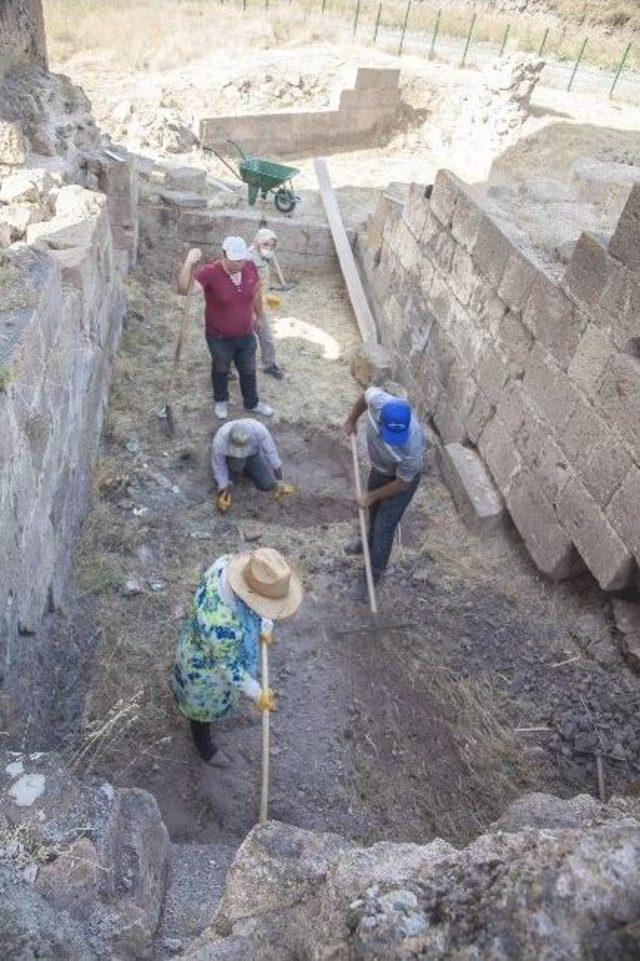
50,256,637,845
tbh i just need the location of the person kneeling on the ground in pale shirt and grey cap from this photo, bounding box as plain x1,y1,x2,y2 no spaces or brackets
211,417,282,503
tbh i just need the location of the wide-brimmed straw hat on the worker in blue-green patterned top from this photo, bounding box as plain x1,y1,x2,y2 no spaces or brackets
227,547,303,621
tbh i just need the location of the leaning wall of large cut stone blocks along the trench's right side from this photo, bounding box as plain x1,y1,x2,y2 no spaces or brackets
359,171,640,590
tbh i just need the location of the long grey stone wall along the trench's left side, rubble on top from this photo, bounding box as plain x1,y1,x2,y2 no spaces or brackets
0,164,136,707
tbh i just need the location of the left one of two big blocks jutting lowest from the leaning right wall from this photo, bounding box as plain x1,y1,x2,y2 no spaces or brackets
507,471,578,580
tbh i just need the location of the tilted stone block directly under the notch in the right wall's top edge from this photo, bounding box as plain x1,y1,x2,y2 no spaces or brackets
522,274,586,370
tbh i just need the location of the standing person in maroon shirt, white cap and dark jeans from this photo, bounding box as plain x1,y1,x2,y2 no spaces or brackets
178,237,273,420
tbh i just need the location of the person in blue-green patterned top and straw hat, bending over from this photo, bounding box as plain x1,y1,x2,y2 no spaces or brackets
171,548,303,761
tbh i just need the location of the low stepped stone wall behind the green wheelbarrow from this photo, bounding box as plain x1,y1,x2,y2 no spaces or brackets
200,67,400,157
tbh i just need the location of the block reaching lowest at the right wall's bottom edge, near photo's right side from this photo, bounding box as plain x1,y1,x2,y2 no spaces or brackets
557,478,633,591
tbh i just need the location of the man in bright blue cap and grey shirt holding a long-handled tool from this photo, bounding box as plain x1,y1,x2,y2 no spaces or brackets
345,387,425,597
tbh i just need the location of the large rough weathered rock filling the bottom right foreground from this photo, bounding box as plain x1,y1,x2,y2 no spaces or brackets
184,795,640,961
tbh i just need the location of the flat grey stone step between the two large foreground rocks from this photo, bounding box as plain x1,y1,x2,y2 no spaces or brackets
153,844,236,961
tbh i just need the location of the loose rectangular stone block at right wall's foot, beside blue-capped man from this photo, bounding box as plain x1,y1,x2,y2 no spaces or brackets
442,444,505,533
